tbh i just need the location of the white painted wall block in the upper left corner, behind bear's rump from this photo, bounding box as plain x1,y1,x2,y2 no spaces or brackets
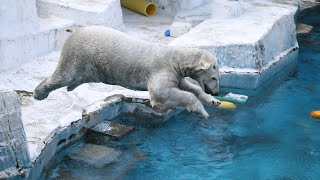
0,0,73,70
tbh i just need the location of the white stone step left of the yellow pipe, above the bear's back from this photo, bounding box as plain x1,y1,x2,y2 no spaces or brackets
37,0,123,29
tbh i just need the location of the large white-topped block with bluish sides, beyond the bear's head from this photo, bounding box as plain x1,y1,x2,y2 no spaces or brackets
169,2,298,89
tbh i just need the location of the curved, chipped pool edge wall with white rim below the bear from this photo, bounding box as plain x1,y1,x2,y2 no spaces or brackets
28,94,180,179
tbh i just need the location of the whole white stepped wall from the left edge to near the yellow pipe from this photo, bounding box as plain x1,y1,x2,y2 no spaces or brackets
0,0,123,70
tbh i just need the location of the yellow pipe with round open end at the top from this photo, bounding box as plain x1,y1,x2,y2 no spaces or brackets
121,0,157,16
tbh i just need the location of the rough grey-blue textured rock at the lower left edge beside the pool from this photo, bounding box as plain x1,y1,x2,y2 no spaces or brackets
0,89,30,179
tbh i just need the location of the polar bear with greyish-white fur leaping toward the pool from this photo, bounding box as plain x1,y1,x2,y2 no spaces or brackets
34,26,220,118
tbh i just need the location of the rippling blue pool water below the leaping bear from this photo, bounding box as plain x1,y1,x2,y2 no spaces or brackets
45,7,320,180
